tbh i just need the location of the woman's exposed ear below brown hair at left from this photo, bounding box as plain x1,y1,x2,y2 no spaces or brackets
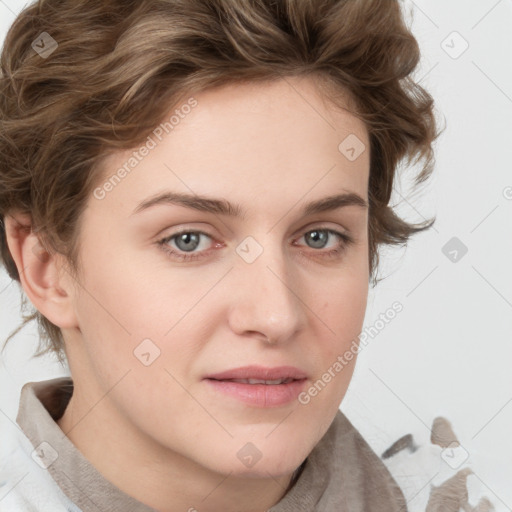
4,213,77,328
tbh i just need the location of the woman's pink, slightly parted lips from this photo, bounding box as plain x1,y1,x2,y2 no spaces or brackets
204,365,307,408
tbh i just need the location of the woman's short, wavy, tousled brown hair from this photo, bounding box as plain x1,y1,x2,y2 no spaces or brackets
0,0,438,361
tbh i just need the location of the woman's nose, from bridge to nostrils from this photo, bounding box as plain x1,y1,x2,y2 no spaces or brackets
229,239,307,343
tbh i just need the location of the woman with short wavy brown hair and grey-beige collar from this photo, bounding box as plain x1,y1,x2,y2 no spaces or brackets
0,0,436,512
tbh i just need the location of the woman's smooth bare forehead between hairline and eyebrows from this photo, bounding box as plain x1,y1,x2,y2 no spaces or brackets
92,77,369,218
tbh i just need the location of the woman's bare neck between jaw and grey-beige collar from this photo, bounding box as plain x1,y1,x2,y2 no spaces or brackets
57,388,303,512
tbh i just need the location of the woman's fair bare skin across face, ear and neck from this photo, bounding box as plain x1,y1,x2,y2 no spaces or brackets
6,78,369,512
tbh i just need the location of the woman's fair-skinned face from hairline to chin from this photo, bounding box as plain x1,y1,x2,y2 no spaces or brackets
64,78,369,477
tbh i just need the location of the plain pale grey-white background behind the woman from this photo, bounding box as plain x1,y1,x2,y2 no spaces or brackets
0,0,512,510
